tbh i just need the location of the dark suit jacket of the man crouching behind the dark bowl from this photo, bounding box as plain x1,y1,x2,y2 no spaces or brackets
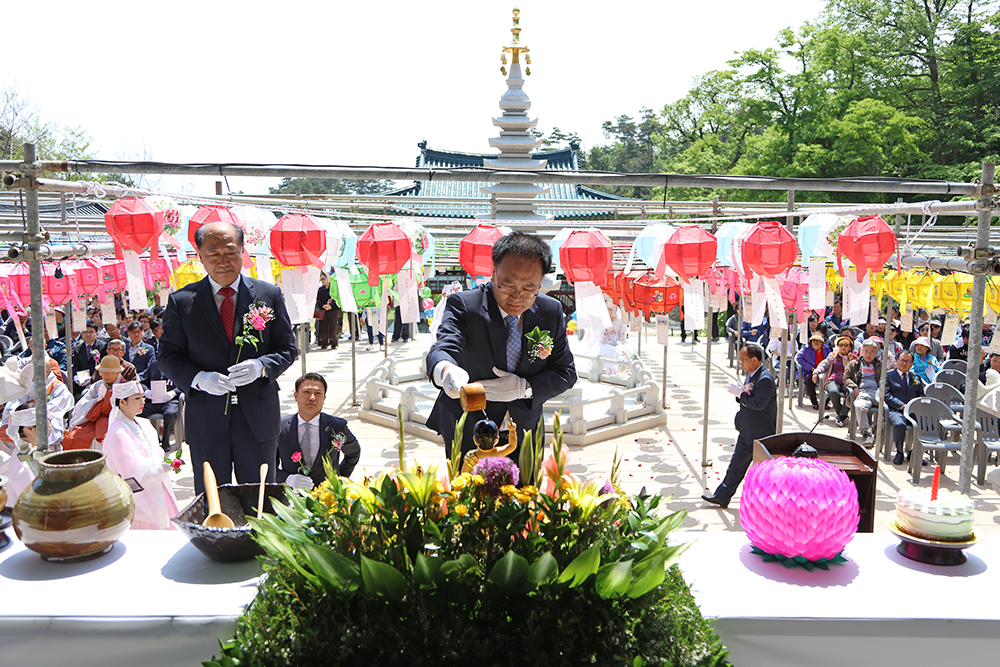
274,412,361,486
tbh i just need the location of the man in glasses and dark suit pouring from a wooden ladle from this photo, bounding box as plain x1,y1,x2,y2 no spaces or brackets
427,232,576,459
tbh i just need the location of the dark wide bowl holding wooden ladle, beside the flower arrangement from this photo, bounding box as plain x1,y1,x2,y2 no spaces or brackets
172,484,285,563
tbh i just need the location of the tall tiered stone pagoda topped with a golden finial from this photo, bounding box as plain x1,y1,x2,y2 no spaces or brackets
477,8,552,220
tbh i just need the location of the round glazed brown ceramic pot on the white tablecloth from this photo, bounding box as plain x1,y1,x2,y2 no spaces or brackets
13,449,135,562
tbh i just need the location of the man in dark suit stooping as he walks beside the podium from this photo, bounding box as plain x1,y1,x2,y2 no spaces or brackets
702,343,778,507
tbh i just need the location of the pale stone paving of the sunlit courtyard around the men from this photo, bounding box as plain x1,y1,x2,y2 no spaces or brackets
174,328,1000,533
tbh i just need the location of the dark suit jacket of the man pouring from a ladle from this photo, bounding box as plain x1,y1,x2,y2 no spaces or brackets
427,283,576,455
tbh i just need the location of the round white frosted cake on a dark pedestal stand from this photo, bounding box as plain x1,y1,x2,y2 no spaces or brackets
896,488,975,542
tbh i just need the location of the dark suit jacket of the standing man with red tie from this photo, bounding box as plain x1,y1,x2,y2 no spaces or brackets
157,276,298,447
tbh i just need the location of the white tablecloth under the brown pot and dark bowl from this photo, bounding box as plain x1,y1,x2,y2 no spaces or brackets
0,528,258,667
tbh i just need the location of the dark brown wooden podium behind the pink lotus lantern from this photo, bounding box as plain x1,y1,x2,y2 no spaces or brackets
753,432,878,533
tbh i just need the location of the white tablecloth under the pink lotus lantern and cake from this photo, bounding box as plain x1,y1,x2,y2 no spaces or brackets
673,532,1000,667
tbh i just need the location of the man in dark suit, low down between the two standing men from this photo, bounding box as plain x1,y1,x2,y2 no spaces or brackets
275,373,361,489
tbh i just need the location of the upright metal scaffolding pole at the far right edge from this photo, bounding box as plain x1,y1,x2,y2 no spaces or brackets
956,162,996,493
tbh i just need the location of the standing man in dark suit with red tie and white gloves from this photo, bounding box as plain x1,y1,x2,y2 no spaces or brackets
158,222,298,493
